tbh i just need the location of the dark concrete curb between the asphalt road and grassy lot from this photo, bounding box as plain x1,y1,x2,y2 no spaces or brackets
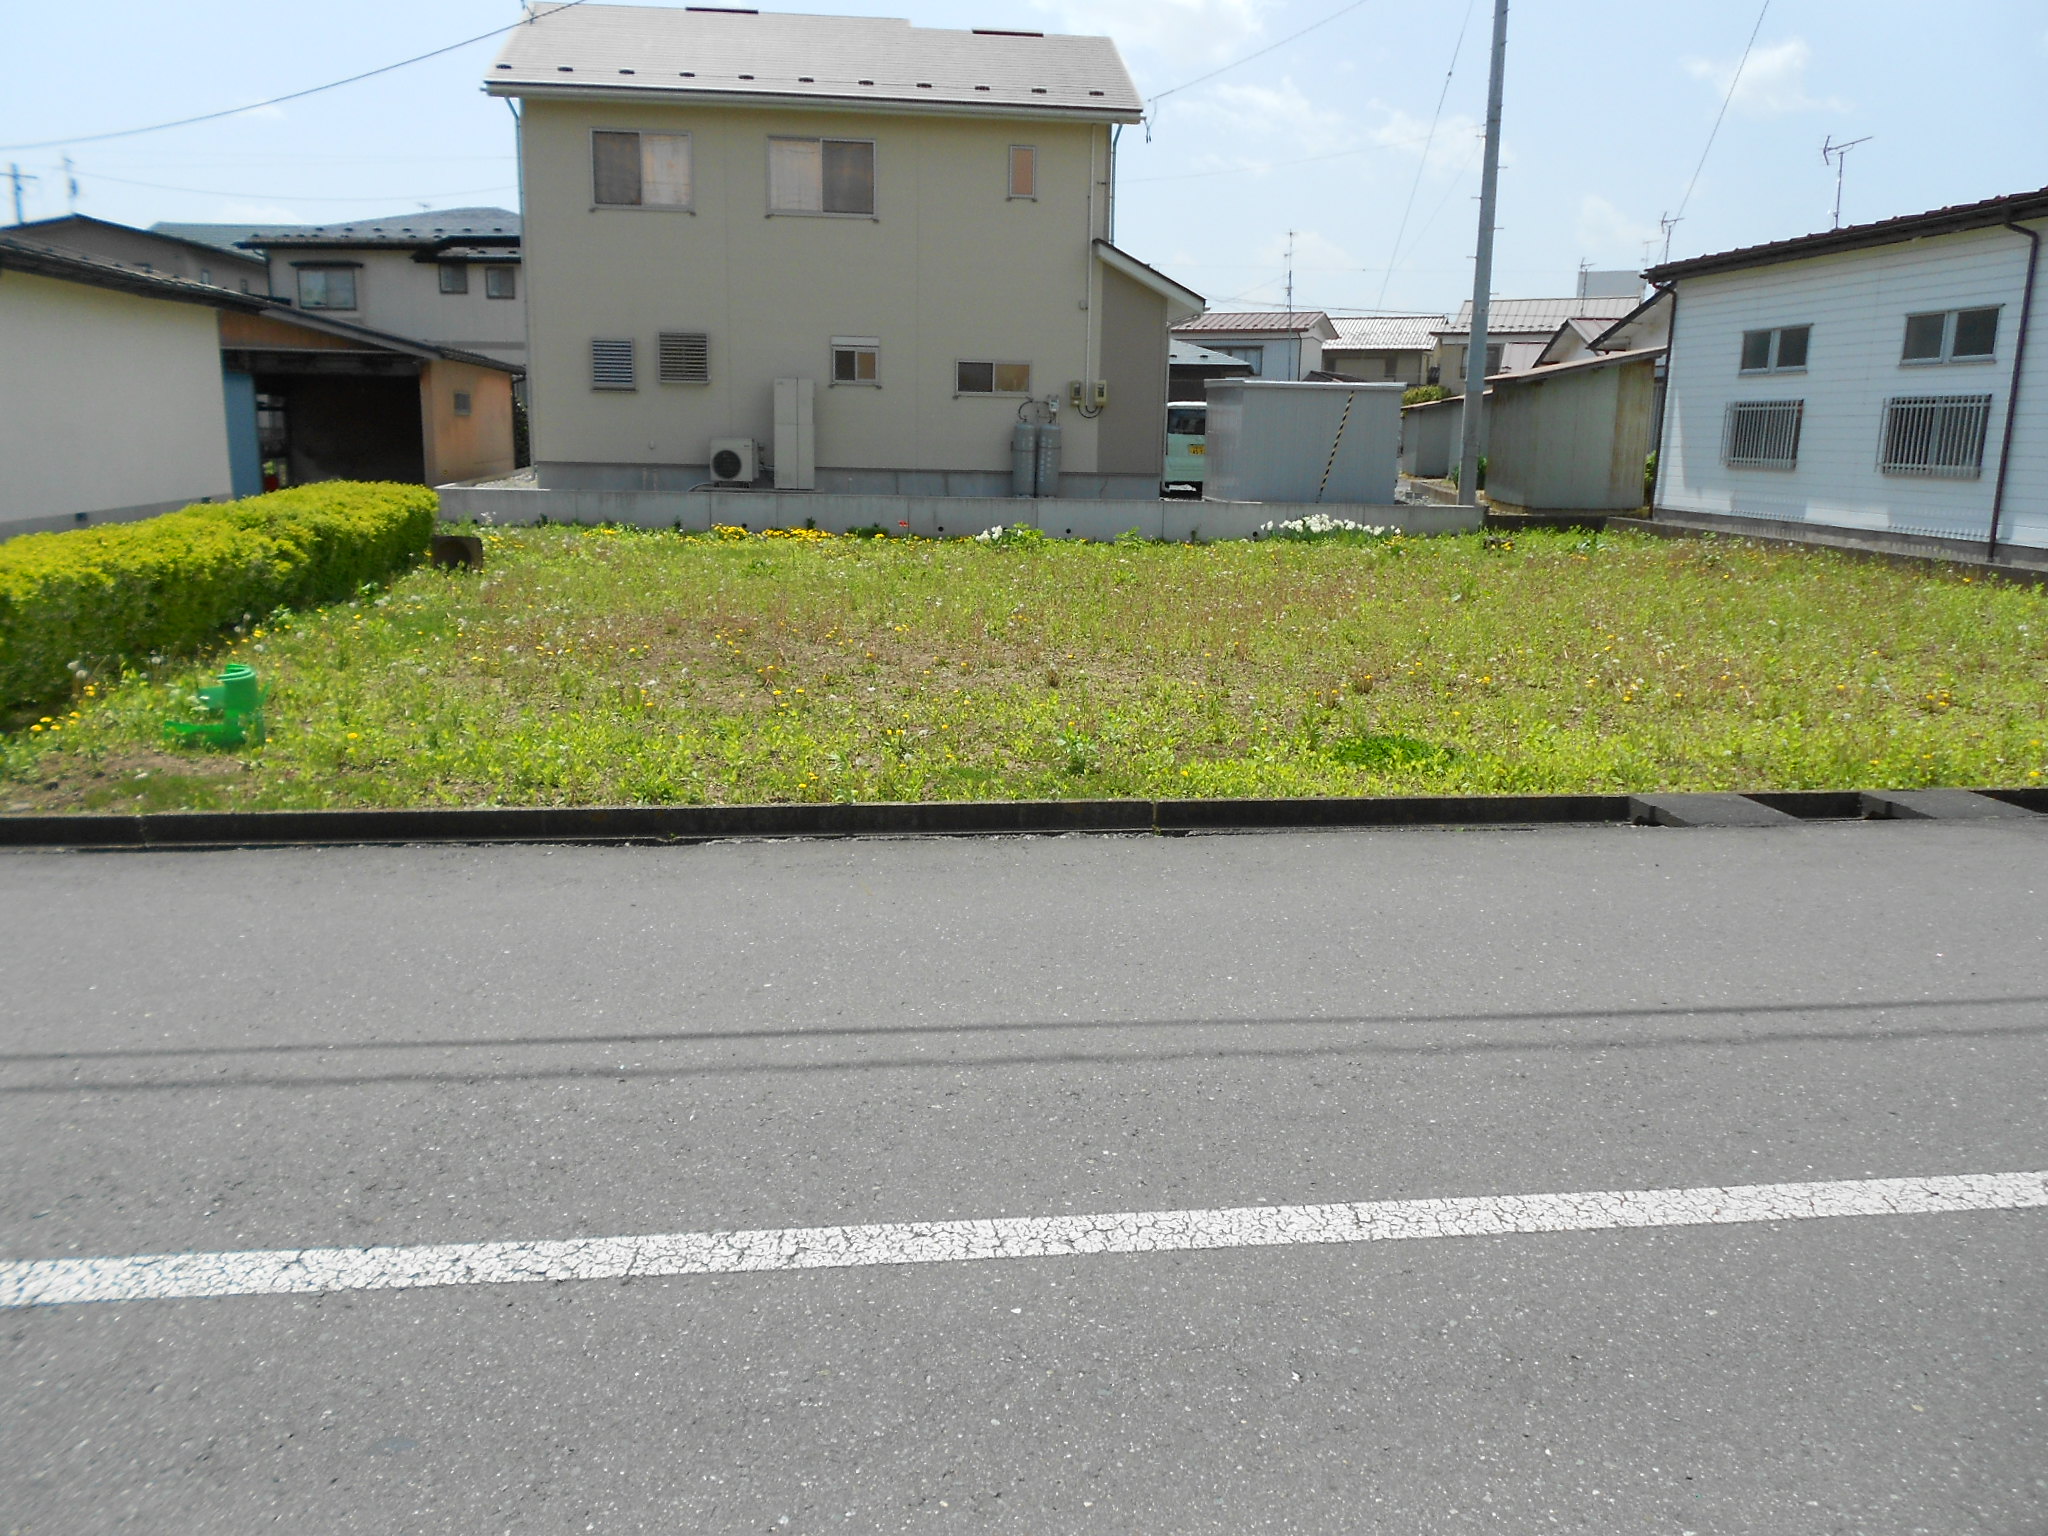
0,788,2048,848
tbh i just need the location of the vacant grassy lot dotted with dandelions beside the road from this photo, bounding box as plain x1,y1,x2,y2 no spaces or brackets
0,528,2048,811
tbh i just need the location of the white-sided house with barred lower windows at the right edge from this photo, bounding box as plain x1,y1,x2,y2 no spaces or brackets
1647,188,2048,549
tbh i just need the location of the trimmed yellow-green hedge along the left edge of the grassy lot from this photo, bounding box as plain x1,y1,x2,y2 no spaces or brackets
0,479,440,705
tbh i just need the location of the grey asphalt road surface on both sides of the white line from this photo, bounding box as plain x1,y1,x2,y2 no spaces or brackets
0,817,2048,1536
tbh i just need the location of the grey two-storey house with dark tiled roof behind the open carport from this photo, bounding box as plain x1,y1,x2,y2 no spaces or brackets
154,209,526,369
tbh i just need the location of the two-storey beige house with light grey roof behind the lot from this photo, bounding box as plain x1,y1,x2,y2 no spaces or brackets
485,4,1202,498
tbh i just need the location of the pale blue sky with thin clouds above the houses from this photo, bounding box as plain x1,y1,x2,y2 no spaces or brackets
0,0,2048,311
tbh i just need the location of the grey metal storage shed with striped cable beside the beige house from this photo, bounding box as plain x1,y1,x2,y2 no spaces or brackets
1202,379,1405,504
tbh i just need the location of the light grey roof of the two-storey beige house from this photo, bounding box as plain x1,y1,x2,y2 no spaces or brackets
483,4,1145,123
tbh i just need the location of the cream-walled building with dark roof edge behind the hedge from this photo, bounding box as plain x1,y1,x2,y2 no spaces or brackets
0,231,245,537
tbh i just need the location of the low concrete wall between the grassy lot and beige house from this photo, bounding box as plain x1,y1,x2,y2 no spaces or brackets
440,485,1479,541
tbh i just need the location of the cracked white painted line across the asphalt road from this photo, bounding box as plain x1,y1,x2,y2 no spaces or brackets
0,1171,2048,1309
